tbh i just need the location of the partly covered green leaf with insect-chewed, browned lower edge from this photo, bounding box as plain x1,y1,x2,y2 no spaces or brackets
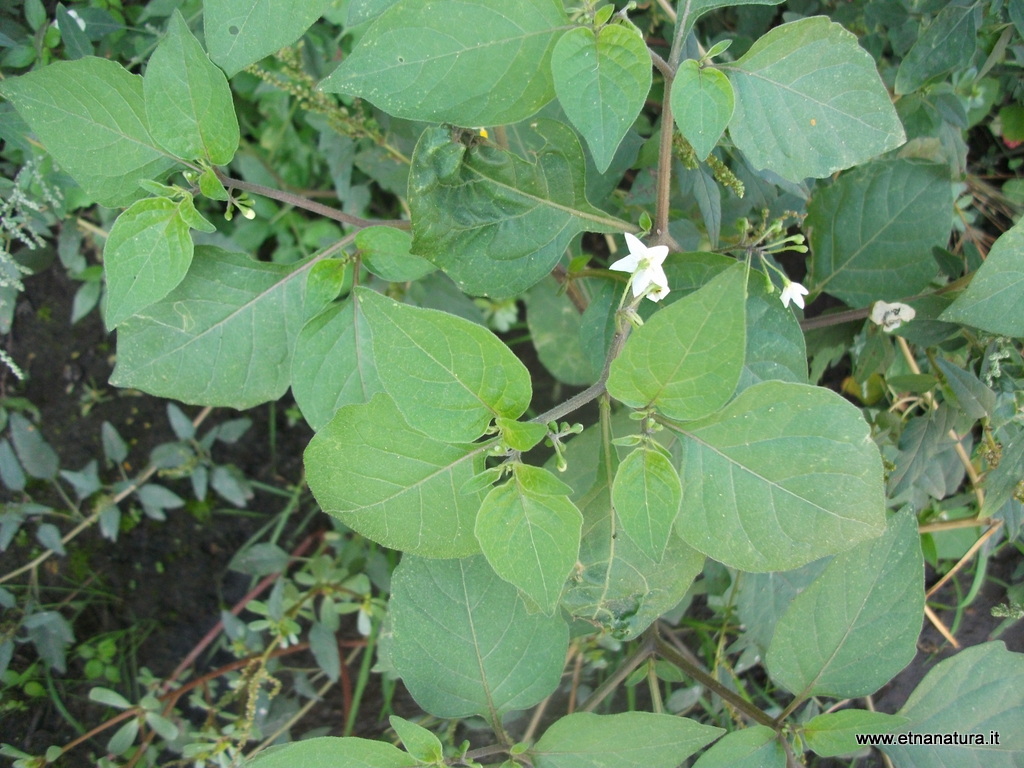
562,414,705,640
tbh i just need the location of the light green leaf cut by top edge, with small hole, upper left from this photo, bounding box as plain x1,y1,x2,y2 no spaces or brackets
203,0,334,77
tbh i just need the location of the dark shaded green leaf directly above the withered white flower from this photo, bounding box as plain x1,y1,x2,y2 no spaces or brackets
807,160,952,307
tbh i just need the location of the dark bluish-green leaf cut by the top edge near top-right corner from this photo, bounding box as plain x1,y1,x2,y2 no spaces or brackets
894,0,981,95
